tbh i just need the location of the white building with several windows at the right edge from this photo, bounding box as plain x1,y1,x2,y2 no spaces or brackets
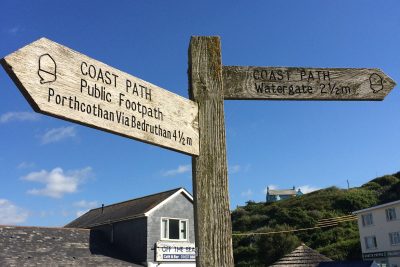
353,200,400,267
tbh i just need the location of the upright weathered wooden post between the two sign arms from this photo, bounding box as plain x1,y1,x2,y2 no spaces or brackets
188,37,233,267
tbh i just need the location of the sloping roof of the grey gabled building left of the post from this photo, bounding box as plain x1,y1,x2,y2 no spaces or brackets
65,188,193,228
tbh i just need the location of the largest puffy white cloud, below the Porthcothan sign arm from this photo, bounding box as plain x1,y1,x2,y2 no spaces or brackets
22,167,92,198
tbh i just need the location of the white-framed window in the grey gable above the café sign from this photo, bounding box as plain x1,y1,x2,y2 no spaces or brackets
161,218,188,240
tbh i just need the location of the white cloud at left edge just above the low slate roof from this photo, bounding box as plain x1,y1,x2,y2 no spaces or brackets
0,199,29,224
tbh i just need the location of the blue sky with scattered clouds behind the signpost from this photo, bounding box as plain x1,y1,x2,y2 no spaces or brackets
0,0,400,226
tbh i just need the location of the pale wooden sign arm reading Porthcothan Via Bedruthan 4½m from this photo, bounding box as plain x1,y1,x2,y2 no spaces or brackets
1,38,199,155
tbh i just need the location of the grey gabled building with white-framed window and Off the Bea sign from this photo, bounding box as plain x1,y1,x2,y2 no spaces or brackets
65,188,196,267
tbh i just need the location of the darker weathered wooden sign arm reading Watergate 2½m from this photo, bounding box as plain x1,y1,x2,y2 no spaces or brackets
223,66,396,100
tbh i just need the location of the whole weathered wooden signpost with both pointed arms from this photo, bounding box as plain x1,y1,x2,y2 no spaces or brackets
1,37,395,267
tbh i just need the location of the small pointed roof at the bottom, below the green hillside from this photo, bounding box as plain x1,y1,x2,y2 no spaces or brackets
271,244,332,267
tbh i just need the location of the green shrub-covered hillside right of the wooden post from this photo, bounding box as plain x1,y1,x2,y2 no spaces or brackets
232,172,400,266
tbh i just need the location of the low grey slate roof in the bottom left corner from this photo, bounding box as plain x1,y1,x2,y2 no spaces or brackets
0,226,141,267
